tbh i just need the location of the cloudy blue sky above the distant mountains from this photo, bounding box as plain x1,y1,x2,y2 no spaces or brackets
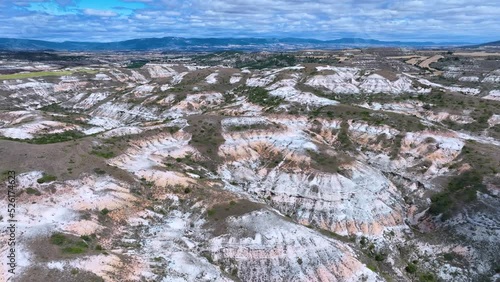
0,0,500,43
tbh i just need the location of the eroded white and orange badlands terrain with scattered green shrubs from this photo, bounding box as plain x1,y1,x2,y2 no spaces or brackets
0,49,500,281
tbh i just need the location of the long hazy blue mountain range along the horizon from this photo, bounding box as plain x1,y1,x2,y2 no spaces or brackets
0,37,476,51
